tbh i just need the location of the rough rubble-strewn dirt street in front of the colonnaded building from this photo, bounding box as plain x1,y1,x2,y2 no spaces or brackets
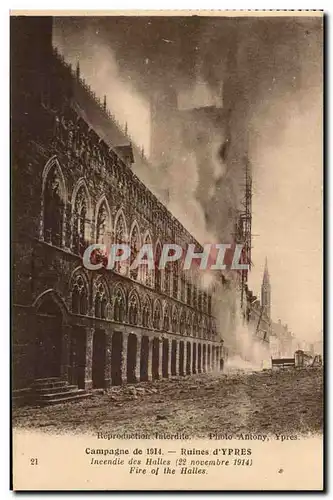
13,368,323,437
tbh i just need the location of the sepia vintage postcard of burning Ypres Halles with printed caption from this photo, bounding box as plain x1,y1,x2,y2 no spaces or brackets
10,11,324,491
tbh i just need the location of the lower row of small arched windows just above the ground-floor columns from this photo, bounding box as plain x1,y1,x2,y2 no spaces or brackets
71,273,213,338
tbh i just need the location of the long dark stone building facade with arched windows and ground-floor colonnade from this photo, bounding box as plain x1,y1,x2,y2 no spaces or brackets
11,18,223,396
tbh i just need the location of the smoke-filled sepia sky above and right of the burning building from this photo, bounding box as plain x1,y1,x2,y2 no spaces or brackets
54,16,323,339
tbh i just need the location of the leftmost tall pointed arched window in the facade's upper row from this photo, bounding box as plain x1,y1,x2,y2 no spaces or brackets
43,168,64,246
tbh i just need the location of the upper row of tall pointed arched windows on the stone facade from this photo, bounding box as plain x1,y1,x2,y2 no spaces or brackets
40,158,211,314
